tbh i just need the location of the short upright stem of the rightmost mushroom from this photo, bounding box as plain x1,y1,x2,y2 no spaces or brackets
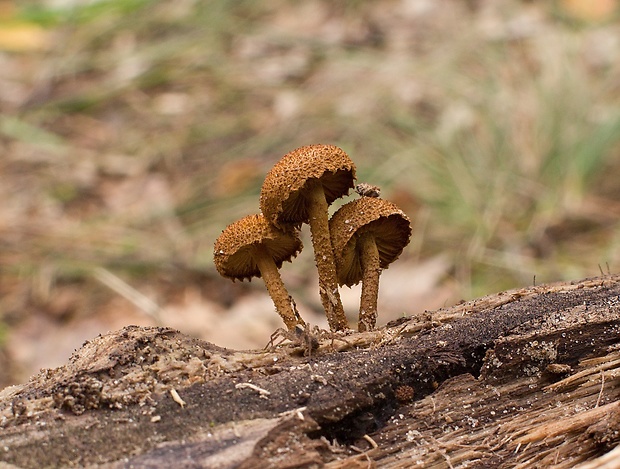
357,233,381,332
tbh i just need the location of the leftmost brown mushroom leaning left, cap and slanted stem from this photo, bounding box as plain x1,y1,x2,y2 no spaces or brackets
213,215,304,330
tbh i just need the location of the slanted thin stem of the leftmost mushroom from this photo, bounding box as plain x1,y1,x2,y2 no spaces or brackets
252,244,305,330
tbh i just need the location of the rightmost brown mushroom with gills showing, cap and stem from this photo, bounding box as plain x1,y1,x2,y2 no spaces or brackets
329,197,411,332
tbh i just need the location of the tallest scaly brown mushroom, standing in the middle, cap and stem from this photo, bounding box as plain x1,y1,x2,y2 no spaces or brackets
260,145,355,331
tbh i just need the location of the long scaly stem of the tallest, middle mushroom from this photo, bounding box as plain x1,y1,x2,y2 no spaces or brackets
307,180,348,331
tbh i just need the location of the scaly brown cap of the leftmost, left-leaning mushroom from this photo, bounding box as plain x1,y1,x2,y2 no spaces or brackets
213,214,303,281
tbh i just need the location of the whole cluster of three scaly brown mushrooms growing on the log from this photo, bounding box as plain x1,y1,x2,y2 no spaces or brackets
214,145,411,331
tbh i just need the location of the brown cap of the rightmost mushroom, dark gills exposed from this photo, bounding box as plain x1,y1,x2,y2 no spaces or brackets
329,197,411,287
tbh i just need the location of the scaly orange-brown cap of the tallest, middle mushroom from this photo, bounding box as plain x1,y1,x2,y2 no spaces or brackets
260,144,355,226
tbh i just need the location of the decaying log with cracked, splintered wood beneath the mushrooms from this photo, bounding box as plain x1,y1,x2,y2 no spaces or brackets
0,276,620,469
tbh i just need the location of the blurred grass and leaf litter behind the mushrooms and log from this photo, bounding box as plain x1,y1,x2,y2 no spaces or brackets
0,0,620,387
